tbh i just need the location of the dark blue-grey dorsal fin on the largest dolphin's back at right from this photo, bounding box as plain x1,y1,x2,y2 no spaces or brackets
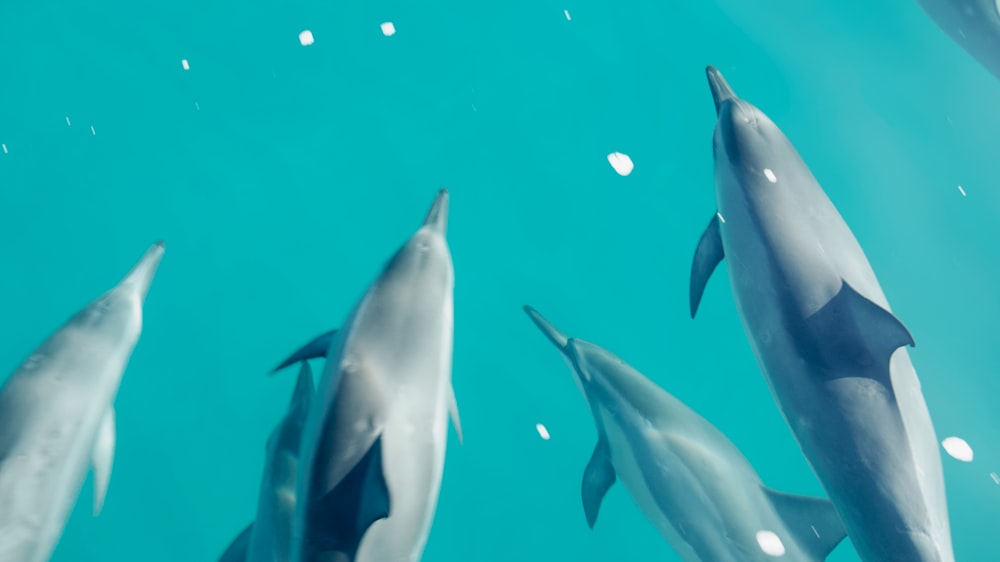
806,281,914,378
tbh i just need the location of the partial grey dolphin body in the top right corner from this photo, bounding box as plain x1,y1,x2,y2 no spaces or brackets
917,0,1000,78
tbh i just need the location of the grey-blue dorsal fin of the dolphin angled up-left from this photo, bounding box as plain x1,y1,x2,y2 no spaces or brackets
761,486,847,560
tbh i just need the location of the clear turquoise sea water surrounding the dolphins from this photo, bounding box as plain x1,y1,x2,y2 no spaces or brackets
0,0,1000,562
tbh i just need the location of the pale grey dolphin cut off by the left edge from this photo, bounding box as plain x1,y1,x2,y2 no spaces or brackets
0,242,164,562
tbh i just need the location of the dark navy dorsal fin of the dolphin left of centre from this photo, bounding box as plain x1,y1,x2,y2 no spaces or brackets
307,435,389,561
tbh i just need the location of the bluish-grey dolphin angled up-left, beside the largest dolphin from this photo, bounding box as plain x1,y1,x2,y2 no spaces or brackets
524,306,844,562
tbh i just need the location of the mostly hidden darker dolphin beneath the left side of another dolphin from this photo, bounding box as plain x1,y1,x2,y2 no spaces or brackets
219,361,313,562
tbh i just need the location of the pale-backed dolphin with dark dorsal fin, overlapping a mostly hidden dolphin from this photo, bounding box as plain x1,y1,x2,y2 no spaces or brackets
282,189,462,562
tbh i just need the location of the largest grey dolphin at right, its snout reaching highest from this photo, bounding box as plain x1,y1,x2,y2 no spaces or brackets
690,66,954,562
